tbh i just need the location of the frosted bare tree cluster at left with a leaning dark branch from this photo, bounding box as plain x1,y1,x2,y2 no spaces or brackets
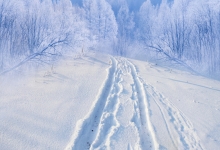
0,0,86,72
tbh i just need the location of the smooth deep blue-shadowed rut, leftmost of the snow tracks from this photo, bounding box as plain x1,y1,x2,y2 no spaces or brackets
66,58,117,150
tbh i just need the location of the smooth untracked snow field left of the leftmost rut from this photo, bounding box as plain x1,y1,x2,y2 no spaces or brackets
0,53,109,150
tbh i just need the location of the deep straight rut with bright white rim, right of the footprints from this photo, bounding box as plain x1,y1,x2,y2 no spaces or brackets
127,61,159,149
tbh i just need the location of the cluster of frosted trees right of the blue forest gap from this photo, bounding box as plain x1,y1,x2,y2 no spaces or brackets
139,0,220,74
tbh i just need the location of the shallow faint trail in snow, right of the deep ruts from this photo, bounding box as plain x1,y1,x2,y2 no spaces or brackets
142,80,203,150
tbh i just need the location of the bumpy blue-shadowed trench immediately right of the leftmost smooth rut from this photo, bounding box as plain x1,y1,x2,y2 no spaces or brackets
91,58,123,149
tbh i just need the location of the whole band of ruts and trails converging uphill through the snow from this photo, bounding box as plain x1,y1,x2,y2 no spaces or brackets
66,57,203,150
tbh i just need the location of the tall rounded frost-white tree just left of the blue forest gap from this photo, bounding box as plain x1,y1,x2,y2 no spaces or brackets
83,0,117,51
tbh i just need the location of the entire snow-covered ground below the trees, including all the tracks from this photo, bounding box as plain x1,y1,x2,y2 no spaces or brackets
0,53,220,150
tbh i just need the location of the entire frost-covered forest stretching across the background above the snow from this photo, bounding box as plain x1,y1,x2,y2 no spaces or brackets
0,0,220,76
